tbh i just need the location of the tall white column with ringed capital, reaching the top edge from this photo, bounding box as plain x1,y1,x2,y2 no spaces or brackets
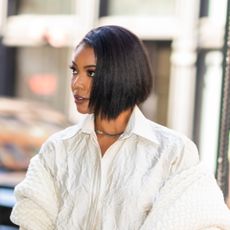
168,0,199,138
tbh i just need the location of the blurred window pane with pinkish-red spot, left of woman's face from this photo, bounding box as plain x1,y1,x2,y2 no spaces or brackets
16,46,70,112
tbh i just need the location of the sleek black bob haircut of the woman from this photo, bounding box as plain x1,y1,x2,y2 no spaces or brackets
79,25,152,120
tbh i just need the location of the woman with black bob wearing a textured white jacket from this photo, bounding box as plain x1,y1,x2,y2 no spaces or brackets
11,26,230,230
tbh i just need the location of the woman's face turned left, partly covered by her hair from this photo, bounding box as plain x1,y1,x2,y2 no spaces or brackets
70,44,96,114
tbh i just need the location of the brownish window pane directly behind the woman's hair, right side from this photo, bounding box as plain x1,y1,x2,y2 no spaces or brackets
141,41,171,125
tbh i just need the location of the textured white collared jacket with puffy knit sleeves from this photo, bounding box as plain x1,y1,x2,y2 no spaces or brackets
11,107,230,230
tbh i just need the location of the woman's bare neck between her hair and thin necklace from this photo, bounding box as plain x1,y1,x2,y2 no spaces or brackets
95,109,132,137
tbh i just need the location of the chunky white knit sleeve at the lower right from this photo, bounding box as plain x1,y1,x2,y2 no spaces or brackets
141,164,230,230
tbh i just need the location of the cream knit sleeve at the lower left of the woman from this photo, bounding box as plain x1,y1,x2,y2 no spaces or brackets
11,154,58,230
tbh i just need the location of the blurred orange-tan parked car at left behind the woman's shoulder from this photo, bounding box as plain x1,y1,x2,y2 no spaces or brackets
0,97,70,227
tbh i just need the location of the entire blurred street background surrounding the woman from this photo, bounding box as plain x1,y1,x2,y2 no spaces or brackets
0,0,230,229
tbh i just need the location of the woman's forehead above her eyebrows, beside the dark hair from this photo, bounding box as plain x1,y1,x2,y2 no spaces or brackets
73,43,96,64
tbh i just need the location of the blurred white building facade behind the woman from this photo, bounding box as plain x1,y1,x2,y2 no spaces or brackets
0,0,227,198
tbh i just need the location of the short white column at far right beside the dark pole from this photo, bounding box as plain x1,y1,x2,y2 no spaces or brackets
198,51,223,173
